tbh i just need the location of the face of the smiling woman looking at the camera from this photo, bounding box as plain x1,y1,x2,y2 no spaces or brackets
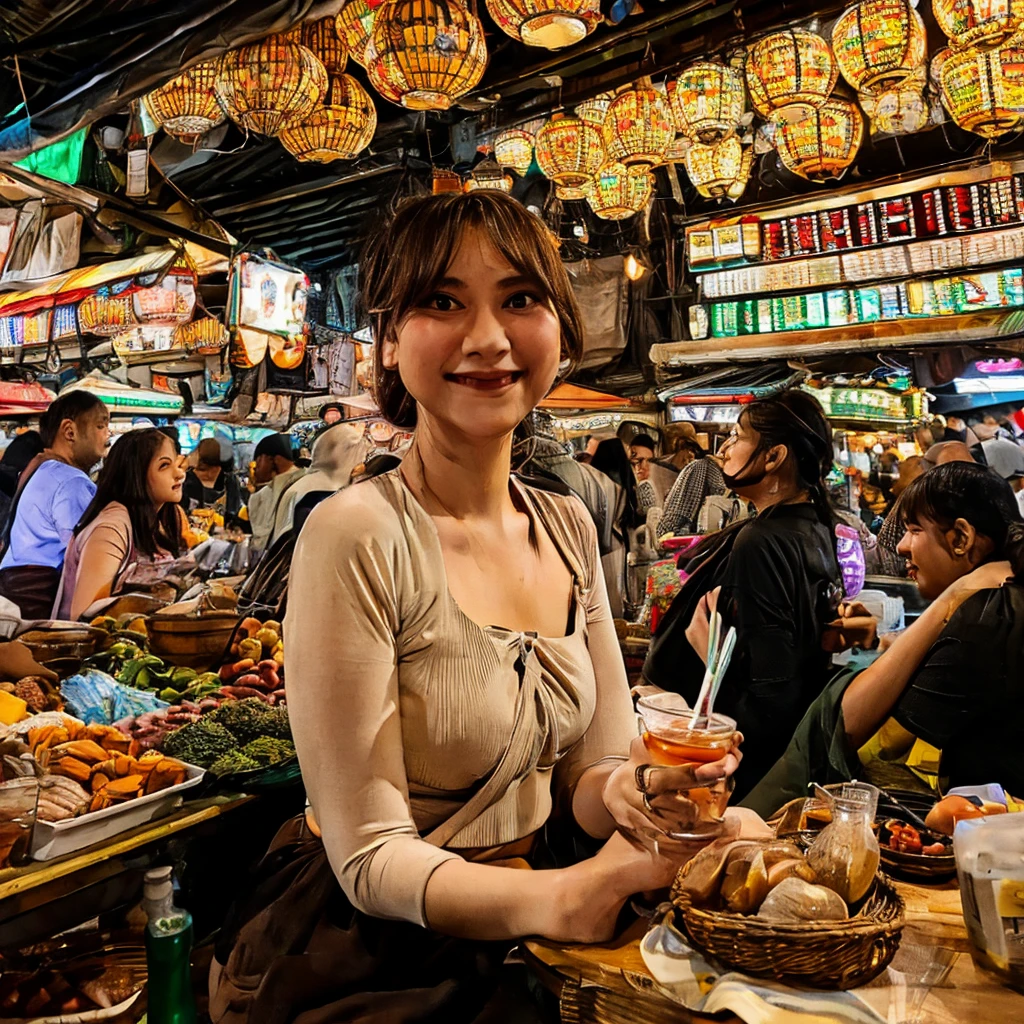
382,230,561,441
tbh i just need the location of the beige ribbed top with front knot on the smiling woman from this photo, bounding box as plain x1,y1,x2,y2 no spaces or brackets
285,470,636,925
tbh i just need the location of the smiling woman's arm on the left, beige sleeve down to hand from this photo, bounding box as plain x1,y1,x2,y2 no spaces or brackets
285,486,675,941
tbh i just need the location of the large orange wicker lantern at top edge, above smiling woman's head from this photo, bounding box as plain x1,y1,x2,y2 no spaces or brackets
373,0,487,111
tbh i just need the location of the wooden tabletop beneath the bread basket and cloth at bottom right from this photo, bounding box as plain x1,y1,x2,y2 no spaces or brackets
520,882,1024,1024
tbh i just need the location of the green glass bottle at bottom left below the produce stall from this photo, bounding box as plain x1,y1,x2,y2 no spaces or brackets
142,867,196,1024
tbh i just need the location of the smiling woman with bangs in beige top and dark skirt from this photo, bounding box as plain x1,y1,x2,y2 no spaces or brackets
211,191,763,1024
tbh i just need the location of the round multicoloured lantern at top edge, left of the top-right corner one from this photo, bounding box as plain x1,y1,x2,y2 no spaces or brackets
833,0,928,92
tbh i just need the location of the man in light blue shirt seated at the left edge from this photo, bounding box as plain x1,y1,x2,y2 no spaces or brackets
0,390,111,618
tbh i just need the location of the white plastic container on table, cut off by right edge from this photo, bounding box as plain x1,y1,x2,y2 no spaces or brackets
953,813,1024,986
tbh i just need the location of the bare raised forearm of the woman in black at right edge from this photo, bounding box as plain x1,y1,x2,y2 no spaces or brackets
843,562,1013,750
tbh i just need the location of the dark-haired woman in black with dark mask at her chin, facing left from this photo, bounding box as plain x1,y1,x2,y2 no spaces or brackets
643,390,842,796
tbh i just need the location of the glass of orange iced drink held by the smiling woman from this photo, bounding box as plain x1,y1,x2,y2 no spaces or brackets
637,693,736,840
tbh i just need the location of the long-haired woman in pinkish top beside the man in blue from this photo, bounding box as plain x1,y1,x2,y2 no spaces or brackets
54,429,185,620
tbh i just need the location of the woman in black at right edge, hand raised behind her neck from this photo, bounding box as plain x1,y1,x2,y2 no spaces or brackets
744,462,1024,814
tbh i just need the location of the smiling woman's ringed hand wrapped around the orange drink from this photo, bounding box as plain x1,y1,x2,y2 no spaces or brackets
602,732,743,845
